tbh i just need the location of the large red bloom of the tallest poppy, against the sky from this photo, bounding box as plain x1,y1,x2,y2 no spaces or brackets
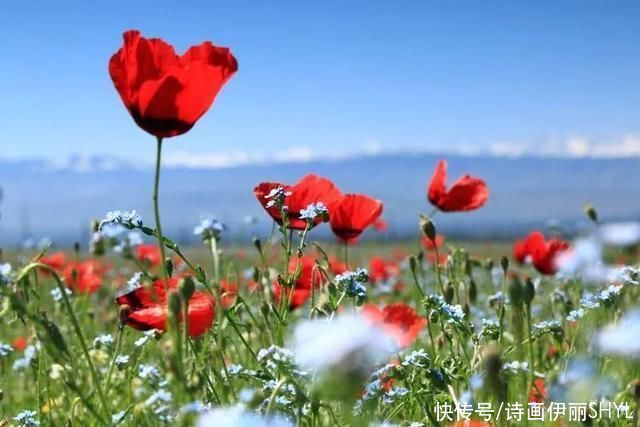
109,31,238,138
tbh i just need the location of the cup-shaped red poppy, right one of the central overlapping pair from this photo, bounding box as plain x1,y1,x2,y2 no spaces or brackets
329,194,382,242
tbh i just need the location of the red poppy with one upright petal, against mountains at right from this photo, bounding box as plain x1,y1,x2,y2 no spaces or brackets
429,160,489,212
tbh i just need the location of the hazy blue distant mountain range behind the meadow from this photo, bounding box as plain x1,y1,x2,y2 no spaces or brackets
0,153,640,246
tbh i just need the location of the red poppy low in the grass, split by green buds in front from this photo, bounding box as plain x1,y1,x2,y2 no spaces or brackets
116,277,215,337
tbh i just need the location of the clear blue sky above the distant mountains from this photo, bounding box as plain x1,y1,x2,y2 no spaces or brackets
0,0,640,162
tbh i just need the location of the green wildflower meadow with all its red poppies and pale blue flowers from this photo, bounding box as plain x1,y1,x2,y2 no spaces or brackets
0,30,640,427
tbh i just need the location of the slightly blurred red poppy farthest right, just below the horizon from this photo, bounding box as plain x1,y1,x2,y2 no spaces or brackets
513,231,570,275
